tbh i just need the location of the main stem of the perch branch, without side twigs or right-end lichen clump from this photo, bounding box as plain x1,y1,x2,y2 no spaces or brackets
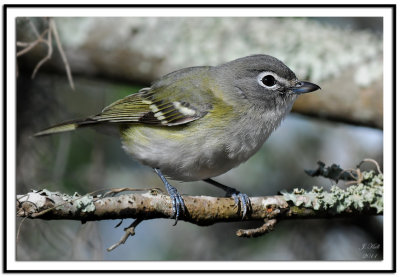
17,184,382,223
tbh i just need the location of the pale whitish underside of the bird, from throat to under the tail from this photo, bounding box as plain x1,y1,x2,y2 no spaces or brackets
122,100,289,181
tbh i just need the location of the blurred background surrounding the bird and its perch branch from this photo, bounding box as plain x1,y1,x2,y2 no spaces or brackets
16,17,383,261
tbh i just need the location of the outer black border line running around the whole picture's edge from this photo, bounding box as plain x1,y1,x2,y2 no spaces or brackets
2,4,397,273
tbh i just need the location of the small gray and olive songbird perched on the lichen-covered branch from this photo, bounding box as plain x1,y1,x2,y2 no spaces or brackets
35,54,320,225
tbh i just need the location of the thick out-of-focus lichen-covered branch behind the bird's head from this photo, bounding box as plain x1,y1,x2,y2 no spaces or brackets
20,17,383,126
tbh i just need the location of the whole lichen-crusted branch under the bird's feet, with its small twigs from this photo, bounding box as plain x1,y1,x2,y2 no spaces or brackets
16,160,383,251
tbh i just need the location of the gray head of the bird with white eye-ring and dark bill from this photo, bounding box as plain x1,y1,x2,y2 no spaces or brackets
213,55,320,108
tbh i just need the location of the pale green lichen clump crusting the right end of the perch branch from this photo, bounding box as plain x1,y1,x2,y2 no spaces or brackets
281,168,383,214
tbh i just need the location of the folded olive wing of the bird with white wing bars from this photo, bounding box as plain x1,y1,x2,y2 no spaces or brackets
90,67,212,126
